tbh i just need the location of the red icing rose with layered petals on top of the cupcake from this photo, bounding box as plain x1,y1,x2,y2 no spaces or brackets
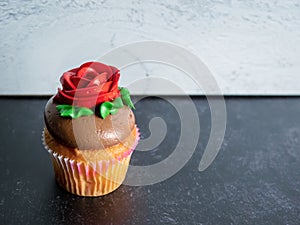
54,62,120,108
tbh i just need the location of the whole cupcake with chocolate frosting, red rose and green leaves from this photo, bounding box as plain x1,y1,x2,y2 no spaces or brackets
43,62,139,196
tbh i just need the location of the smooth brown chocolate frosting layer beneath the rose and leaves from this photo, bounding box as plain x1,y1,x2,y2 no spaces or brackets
44,97,135,150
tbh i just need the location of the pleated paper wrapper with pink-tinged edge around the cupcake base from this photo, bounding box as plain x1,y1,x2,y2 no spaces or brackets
42,128,139,196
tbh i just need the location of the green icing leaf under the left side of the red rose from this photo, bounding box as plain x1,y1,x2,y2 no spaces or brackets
56,105,94,119
